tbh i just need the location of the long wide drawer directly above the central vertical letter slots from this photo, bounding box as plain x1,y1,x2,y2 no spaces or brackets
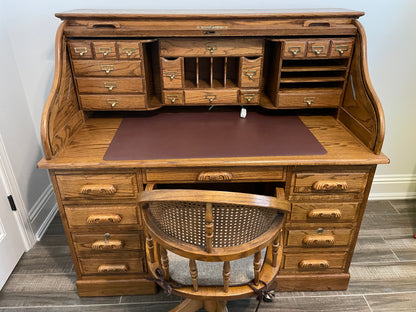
159,38,264,57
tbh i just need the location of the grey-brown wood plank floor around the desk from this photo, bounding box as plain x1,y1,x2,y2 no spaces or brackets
0,200,416,312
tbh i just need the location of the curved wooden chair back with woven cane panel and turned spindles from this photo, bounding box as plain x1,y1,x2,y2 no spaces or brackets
139,186,290,295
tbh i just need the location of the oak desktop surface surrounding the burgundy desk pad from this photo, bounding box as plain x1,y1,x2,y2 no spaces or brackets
38,116,389,169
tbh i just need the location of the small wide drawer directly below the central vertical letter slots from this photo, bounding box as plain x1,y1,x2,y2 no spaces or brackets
185,89,238,105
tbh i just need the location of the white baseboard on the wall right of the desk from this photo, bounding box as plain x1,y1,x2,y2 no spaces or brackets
368,174,416,200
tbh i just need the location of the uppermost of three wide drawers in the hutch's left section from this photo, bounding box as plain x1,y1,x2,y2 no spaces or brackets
72,60,143,77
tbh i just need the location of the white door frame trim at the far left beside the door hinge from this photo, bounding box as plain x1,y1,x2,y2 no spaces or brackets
0,133,36,251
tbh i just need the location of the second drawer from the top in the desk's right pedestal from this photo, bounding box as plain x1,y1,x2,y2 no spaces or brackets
290,203,359,222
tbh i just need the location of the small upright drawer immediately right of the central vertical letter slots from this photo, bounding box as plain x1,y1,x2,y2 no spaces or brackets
240,57,263,88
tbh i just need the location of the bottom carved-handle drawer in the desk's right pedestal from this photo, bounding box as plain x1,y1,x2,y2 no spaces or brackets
282,252,347,274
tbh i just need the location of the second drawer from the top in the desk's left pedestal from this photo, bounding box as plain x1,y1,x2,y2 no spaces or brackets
65,204,142,231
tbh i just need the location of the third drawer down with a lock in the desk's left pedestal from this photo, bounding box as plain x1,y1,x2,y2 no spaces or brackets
72,231,144,257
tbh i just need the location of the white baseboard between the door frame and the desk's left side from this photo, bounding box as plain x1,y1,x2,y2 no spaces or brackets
29,184,58,240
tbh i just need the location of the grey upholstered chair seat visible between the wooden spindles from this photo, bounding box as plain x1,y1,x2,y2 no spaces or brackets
167,248,267,286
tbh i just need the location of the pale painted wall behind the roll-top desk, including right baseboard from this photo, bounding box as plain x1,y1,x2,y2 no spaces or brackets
0,0,416,239
